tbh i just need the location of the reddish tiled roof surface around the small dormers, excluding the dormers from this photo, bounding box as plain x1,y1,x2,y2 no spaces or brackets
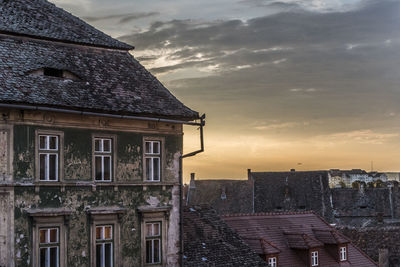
222,212,377,267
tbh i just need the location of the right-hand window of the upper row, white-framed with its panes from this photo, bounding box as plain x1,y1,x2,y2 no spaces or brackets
145,141,161,182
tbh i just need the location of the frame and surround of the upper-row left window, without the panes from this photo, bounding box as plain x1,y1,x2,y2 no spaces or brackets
35,130,64,183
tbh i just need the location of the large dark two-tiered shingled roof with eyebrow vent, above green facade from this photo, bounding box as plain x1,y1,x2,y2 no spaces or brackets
0,0,199,120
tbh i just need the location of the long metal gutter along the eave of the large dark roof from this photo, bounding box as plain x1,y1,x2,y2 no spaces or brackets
0,103,204,126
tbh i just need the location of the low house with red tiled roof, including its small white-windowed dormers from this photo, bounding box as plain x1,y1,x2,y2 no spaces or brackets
222,212,377,267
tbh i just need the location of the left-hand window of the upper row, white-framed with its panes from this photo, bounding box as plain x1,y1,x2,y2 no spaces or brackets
39,135,59,181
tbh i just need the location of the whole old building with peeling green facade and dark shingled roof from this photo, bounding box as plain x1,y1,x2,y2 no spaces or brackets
0,0,204,267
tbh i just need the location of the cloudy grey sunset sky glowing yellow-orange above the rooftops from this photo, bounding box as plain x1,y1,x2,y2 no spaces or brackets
52,0,400,181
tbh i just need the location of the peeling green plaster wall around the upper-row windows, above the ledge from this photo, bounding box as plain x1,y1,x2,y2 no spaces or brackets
14,125,182,182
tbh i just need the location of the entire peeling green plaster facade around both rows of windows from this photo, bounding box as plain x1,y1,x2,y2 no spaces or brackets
13,125,182,266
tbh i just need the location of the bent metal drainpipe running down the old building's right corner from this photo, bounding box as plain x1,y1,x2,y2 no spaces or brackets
179,114,206,267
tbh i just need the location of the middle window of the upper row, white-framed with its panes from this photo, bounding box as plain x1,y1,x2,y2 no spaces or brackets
94,138,113,182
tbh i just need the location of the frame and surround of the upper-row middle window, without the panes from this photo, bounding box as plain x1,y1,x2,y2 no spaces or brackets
92,135,116,183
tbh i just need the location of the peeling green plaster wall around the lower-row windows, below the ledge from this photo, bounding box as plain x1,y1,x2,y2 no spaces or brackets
14,186,172,266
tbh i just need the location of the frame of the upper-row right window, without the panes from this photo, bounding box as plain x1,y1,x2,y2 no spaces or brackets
143,138,163,182
